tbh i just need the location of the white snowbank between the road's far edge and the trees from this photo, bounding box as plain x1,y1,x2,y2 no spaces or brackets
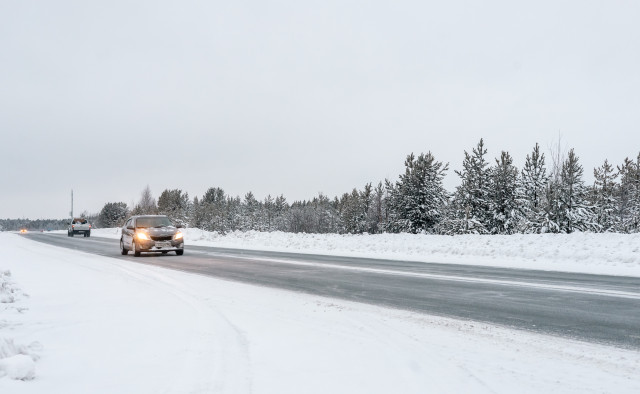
80,228,640,276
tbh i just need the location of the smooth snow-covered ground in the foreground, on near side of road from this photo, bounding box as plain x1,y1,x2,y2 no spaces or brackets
0,232,640,393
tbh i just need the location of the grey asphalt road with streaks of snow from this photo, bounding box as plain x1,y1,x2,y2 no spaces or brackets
26,233,640,349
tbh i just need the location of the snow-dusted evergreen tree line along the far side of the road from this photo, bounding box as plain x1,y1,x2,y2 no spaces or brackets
91,139,640,235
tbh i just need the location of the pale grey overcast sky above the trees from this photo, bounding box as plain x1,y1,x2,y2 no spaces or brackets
0,0,640,219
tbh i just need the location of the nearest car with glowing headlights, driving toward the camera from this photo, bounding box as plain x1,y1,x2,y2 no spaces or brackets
120,215,184,257
